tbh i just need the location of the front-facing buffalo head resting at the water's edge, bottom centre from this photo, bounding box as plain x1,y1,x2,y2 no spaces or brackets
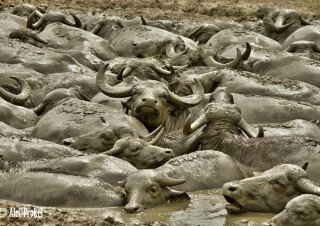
119,170,190,213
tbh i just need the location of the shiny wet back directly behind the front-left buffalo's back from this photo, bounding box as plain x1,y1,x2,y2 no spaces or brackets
22,154,137,186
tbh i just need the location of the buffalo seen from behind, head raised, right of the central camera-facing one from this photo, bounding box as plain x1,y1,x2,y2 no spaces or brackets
184,89,320,179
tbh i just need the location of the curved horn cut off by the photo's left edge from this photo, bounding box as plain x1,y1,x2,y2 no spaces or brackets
0,76,30,105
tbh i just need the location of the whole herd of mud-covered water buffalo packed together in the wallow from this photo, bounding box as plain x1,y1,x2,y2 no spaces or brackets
0,4,320,226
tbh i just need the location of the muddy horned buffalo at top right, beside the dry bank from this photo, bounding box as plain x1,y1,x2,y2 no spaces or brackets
262,9,310,43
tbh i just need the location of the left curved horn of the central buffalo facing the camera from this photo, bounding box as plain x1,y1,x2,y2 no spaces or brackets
96,64,133,98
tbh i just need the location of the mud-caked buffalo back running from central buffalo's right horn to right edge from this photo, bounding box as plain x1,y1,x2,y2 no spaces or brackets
170,67,320,105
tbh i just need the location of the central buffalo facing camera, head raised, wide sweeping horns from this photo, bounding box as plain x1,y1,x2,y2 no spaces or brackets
96,64,204,131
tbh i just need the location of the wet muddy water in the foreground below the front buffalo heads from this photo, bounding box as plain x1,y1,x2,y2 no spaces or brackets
82,189,274,226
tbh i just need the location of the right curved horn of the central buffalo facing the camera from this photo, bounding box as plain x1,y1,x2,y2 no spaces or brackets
168,79,204,108
